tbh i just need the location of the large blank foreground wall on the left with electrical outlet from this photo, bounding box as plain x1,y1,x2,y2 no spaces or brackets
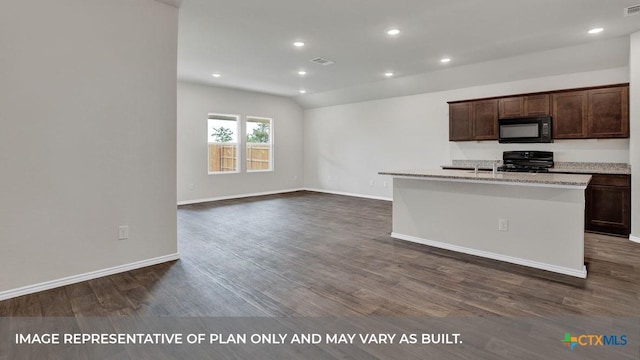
0,0,178,298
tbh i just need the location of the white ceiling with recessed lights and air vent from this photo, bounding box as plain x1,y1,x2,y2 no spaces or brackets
178,0,640,102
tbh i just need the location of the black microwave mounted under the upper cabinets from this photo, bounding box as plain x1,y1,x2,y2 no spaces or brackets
498,116,553,143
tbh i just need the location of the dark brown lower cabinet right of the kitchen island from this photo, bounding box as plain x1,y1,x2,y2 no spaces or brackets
585,174,631,236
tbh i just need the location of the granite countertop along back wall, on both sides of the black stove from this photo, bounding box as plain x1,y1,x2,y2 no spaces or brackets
442,160,631,175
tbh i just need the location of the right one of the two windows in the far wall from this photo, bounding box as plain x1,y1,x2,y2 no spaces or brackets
246,116,273,172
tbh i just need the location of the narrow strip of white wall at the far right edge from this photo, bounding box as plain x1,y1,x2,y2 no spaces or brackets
629,32,640,242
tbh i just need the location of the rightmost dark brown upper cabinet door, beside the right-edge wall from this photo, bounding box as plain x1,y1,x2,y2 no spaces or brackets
588,86,629,138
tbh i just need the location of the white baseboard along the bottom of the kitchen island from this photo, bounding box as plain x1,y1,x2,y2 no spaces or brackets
391,233,587,279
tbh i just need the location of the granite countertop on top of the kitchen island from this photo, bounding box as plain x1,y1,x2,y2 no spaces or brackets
378,169,591,188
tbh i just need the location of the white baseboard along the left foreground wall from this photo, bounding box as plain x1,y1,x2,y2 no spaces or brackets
0,253,180,301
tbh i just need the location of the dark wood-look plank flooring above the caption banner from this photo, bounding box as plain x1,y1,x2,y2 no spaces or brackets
0,192,640,316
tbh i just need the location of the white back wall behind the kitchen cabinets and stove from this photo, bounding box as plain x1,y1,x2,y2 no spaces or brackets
304,64,629,198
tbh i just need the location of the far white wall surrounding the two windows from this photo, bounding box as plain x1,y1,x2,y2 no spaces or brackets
177,82,303,203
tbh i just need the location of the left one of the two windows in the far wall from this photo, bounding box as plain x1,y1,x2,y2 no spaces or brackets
208,114,240,174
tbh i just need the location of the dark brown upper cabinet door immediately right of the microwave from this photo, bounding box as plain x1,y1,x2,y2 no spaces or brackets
551,91,588,139
